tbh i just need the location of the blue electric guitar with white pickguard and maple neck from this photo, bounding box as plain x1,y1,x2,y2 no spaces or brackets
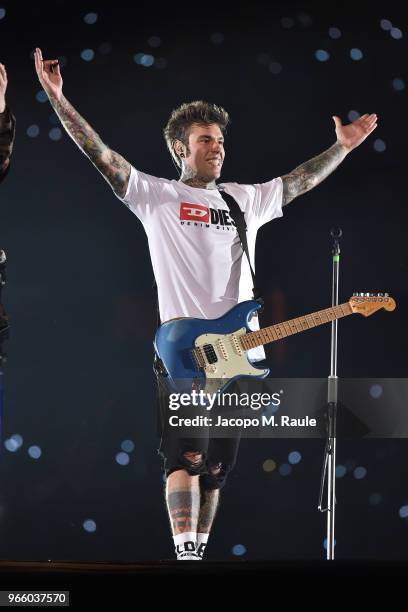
154,293,396,393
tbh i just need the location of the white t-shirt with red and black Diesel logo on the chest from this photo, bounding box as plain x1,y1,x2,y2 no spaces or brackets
119,166,282,360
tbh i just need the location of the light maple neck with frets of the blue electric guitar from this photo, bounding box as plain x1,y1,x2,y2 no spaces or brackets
241,302,353,351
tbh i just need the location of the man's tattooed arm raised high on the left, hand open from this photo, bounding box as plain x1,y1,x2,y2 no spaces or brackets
34,49,130,198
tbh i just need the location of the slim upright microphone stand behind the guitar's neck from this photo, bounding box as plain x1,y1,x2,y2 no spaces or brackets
318,228,343,560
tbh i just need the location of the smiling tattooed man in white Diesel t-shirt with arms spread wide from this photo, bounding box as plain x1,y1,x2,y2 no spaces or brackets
35,49,377,560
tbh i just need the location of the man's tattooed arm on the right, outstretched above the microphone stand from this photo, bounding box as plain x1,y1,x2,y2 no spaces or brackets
281,114,377,206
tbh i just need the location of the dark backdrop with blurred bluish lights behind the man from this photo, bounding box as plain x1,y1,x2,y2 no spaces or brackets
0,1,408,561
